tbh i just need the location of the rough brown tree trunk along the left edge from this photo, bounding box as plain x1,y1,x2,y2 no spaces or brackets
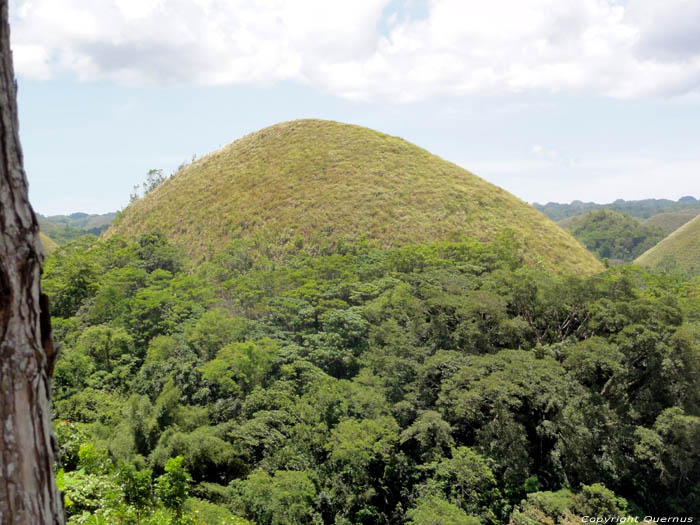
0,0,64,525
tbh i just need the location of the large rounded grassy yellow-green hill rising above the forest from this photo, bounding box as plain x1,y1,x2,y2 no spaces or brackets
107,120,602,273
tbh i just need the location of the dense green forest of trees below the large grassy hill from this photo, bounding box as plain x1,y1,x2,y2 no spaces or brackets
43,232,700,525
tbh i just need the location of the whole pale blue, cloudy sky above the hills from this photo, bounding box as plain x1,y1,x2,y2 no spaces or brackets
10,0,700,215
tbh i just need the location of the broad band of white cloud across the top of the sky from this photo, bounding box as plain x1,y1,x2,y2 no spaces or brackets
12,0,700,102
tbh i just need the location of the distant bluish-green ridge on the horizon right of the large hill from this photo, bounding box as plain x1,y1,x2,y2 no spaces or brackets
533,196,700,221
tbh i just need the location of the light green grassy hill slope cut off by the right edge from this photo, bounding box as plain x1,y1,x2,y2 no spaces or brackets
635,213,700,275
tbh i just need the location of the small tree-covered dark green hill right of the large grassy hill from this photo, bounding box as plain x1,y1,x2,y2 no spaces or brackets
559,210,666,262
